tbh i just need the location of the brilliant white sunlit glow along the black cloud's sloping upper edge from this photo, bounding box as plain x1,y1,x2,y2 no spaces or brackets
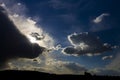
2,3,54,49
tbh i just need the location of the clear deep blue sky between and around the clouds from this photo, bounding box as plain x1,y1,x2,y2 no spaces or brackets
17,0,120,66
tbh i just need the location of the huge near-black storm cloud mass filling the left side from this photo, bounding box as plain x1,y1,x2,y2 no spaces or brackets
0,7,44,67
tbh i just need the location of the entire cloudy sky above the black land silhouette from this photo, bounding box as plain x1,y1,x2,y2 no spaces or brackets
0,0,120,76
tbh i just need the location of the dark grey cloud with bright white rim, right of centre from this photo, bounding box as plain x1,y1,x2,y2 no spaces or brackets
62,32,112,56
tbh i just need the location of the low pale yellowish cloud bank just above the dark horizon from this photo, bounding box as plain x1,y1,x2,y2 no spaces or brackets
9,56,87,75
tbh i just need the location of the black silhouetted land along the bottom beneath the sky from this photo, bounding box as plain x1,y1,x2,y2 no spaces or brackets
0,70,120,80
